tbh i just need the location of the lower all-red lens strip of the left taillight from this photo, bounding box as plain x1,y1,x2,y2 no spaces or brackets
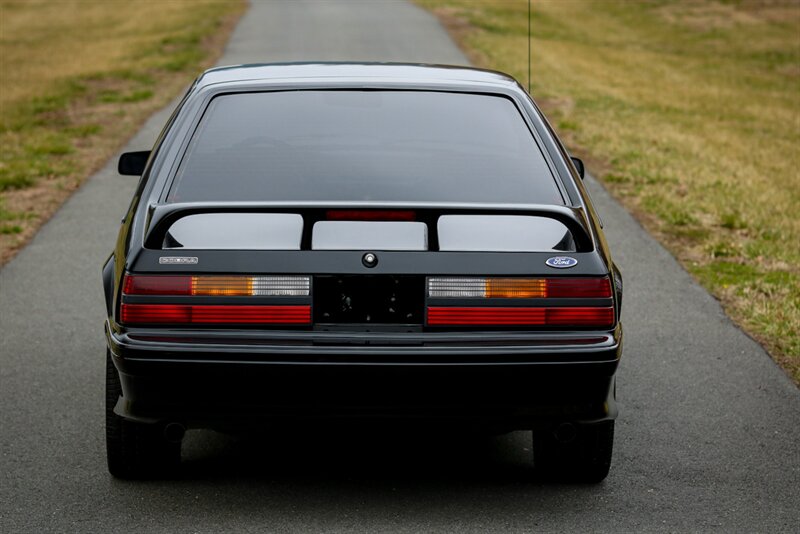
120,303,311,324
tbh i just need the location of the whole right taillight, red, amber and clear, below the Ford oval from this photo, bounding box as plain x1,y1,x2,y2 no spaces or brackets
427,277,615,328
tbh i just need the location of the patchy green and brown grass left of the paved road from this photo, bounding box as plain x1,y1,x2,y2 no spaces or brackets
0,0,245,265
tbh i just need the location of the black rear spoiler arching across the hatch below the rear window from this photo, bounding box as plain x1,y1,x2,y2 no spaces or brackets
144,202,594,252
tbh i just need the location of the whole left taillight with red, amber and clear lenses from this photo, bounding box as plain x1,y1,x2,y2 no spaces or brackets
120,275,311,325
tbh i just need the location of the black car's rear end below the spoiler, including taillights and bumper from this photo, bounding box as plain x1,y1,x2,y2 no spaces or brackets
107,210,621,422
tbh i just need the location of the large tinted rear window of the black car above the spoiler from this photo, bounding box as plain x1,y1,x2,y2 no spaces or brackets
168,91,563,204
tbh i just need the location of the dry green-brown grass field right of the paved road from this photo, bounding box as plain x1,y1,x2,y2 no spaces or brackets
417,0,800,384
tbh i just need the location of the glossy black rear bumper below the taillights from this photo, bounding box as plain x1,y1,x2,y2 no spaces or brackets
106,323,622,430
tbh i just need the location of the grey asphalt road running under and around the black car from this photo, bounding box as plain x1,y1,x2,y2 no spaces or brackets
0,1,800,532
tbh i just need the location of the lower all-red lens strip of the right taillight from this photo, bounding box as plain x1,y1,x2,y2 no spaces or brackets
428,306,614,327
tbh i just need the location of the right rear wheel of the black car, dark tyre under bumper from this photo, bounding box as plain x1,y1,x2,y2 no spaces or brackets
533,421,614,483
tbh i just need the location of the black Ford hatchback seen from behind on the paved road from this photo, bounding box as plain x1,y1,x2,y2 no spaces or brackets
103,63,622,481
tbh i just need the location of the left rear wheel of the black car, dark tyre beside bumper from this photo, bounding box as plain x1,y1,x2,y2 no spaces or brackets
106,350,181,479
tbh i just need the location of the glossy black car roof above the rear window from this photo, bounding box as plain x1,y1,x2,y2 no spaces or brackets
197,62,518,88
